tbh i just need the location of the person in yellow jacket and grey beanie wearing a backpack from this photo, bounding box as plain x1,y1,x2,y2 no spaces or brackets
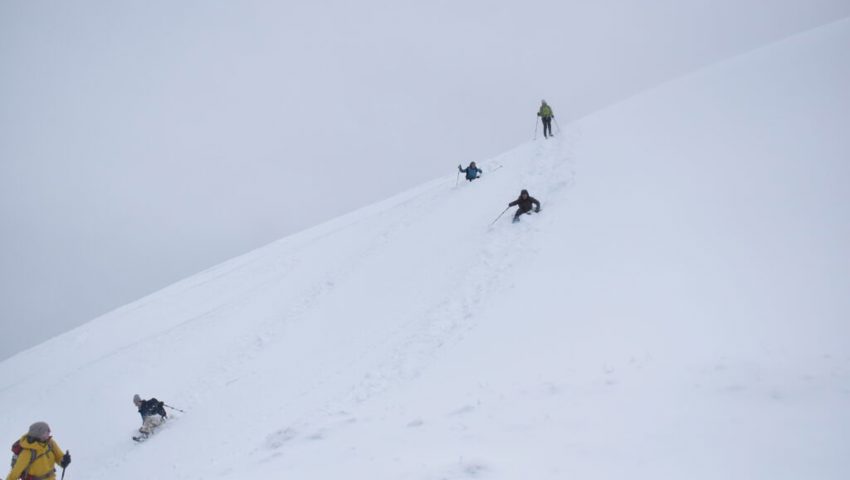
6,422,71,480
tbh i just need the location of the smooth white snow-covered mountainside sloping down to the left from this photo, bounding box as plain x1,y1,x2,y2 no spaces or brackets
0,16,850,480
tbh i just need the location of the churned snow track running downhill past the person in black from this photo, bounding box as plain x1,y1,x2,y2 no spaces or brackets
255,131,579,466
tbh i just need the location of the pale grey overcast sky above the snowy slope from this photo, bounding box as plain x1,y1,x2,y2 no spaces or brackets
0,0,850,358
